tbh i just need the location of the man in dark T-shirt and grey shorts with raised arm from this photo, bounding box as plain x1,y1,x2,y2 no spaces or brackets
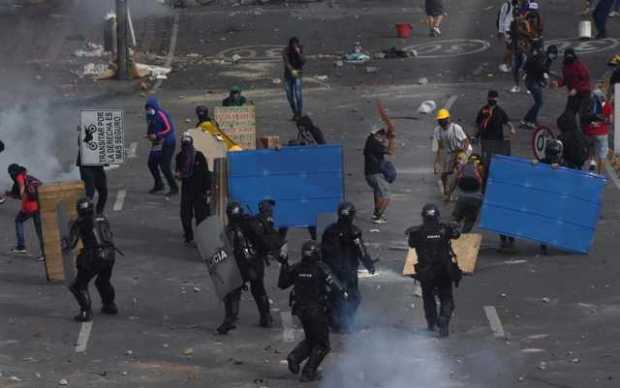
364,101,396,224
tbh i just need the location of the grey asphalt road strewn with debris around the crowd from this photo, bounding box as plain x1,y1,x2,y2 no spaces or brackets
0,0,620,388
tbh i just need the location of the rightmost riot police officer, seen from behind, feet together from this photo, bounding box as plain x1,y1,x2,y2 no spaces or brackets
406,204,461,337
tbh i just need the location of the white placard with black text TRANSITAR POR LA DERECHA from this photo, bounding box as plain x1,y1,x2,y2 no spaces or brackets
80,109,127,166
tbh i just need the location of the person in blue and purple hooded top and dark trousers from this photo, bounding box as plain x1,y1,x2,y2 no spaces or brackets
144,96,179,196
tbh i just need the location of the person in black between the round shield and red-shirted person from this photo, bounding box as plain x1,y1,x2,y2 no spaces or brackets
556,110,588,170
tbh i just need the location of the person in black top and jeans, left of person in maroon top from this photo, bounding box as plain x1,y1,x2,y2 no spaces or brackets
521,44,549,129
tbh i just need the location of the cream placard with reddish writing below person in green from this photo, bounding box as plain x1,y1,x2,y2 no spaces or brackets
213,105,256,150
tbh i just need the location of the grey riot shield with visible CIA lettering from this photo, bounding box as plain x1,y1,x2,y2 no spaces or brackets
196,217,243,299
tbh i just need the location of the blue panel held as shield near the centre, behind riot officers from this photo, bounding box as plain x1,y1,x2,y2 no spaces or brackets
228,145,344,227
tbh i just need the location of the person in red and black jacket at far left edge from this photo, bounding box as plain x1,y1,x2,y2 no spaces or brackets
6,163,45,260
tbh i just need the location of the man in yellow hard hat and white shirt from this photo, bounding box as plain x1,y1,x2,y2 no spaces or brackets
433,109,472,196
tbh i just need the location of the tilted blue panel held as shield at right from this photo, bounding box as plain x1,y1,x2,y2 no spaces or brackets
480,155,607,253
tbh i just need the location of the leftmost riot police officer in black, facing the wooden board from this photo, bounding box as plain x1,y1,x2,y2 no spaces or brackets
63,198,118,322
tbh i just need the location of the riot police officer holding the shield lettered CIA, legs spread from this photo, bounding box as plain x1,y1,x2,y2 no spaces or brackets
217,202,273,334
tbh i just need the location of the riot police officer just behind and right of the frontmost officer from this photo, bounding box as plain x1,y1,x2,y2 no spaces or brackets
321,202,375,331
